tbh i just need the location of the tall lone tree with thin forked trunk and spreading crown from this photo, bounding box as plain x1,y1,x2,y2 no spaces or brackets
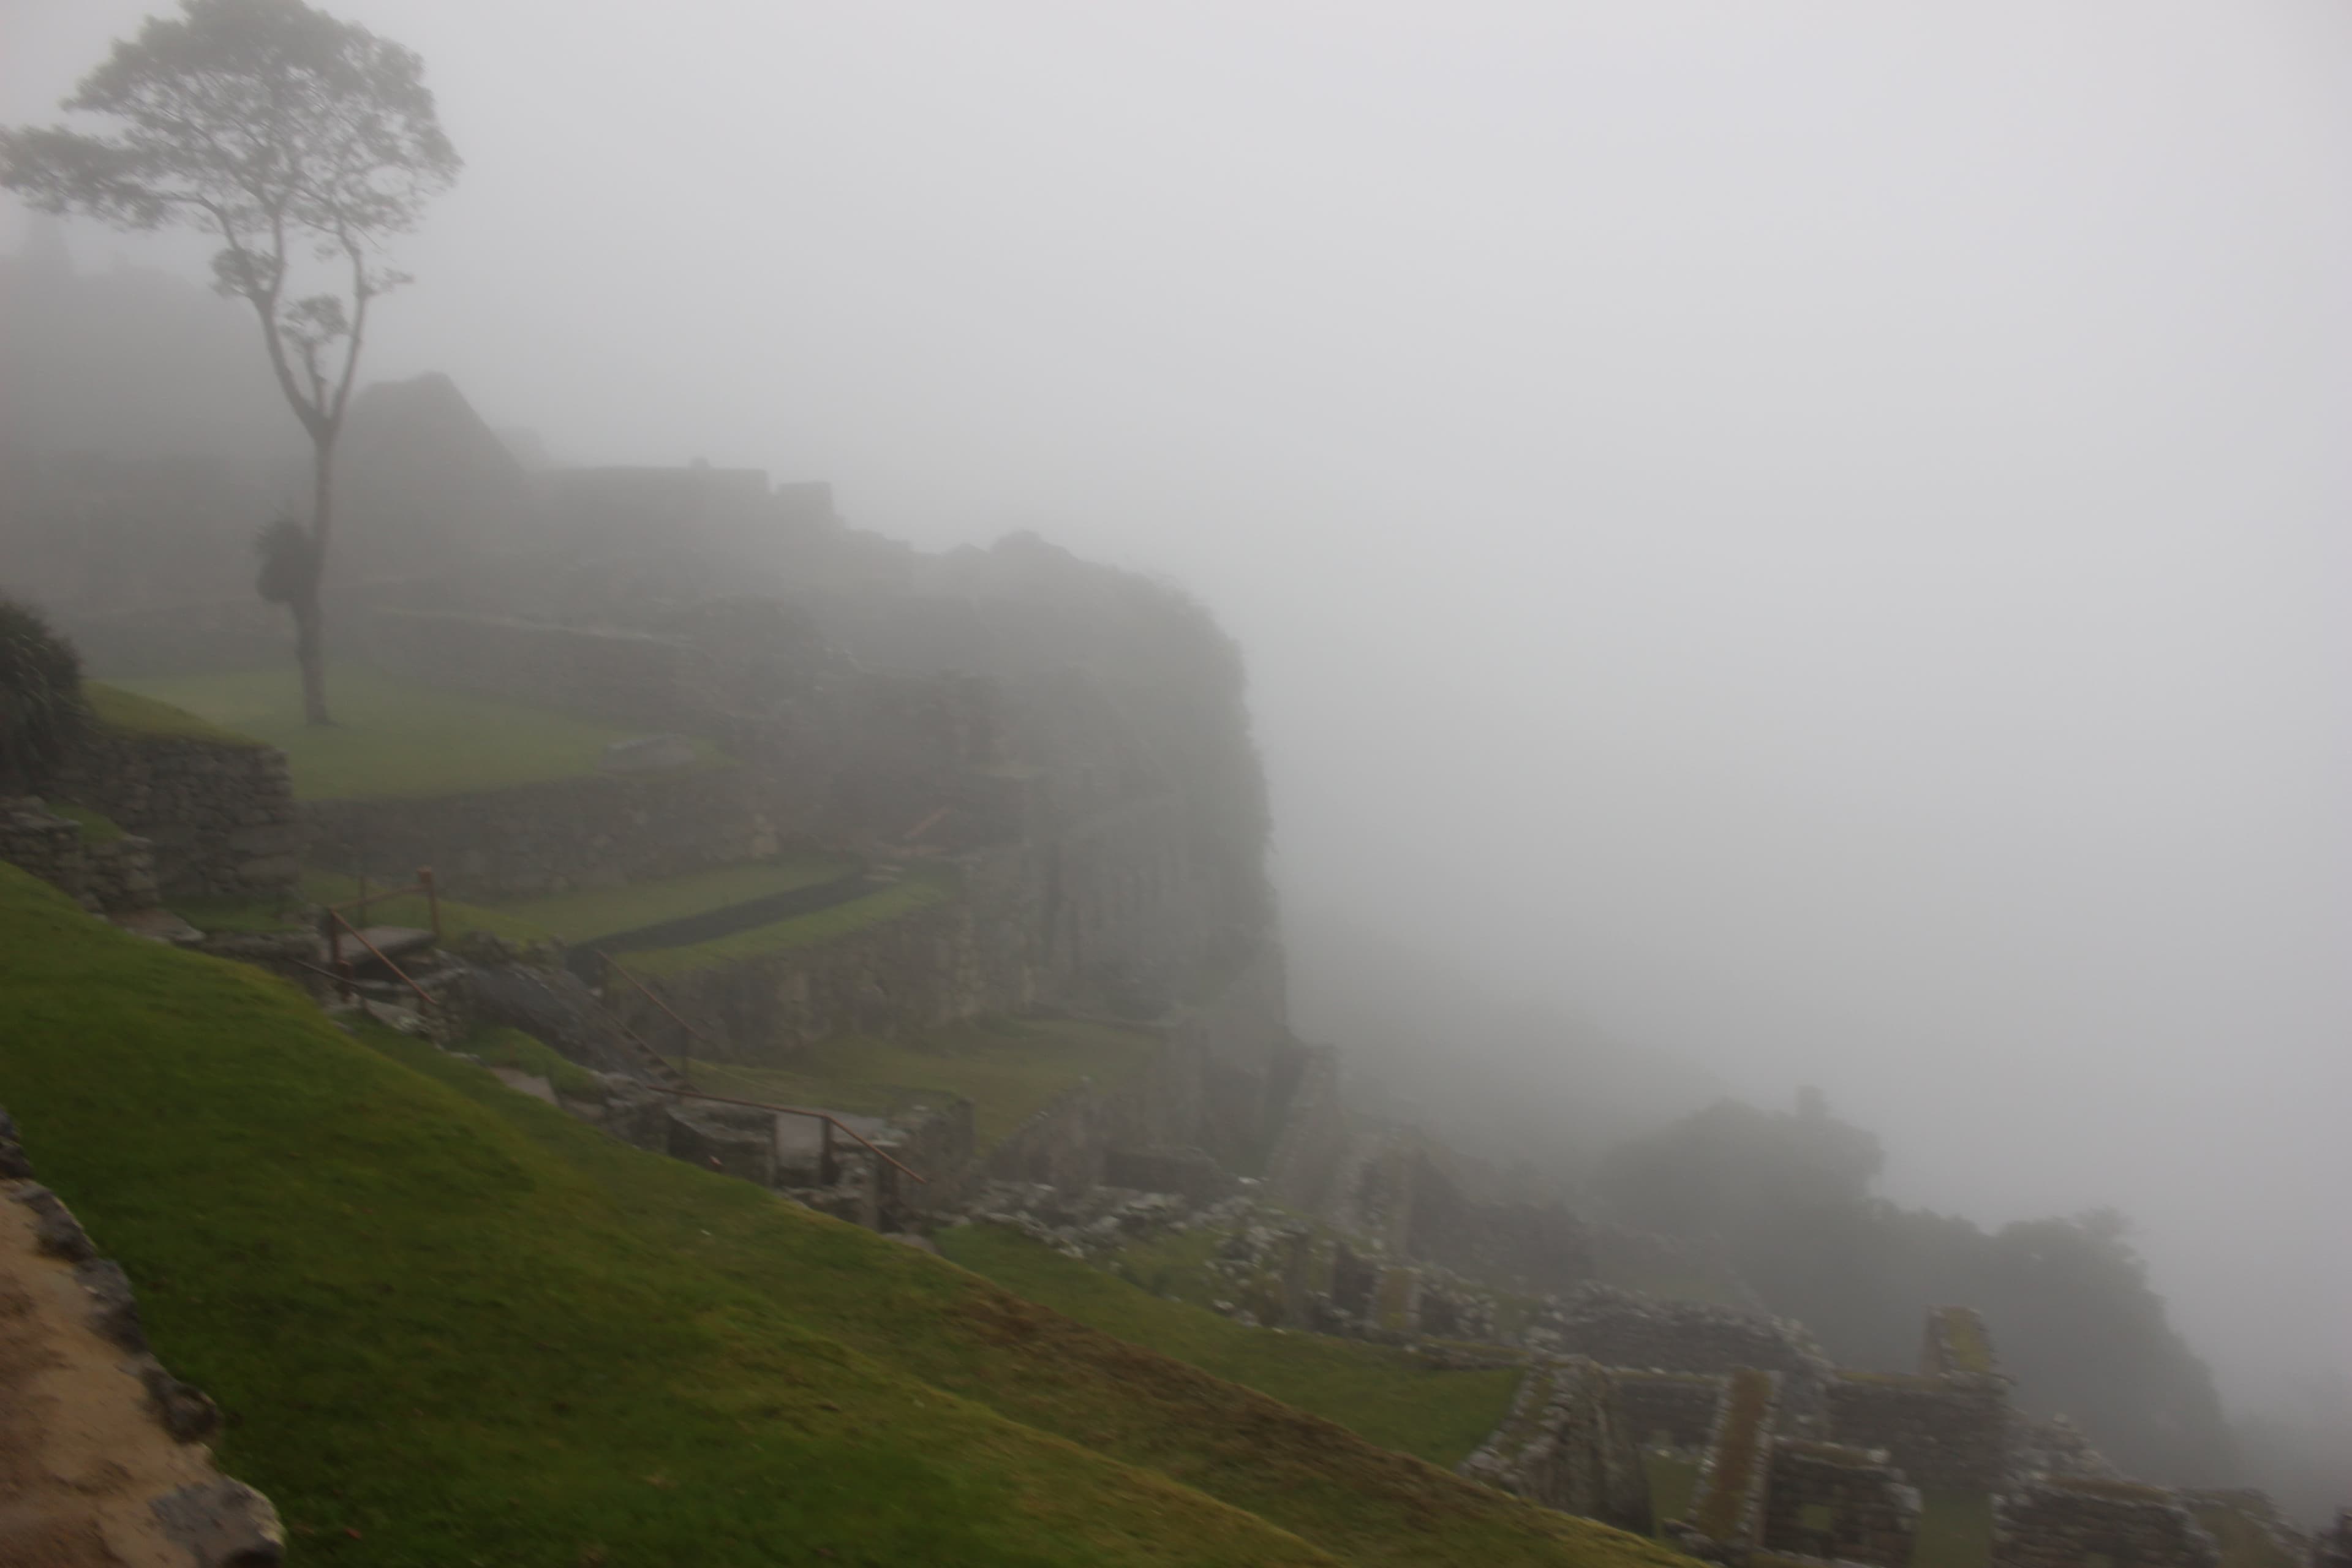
0,0,461,724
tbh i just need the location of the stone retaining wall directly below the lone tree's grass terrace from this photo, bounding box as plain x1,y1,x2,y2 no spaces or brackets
299,766,778,898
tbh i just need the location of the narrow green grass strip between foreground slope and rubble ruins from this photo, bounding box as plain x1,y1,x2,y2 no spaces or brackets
936,1225,1520,1469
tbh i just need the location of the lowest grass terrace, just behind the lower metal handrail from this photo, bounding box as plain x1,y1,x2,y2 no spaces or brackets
682,1011,1159,1150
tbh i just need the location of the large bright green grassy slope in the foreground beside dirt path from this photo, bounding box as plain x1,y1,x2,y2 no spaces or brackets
0,867,1677,1566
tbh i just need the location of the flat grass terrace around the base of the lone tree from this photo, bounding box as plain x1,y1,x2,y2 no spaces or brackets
101,665,722,799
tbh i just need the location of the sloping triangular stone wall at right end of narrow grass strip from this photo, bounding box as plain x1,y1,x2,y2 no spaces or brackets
1458,1359,1651,1535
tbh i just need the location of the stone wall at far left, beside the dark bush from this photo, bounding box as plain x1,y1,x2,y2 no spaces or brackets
56,724,301,900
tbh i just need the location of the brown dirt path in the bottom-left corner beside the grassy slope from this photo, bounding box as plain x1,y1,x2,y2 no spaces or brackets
0,1183,268,1568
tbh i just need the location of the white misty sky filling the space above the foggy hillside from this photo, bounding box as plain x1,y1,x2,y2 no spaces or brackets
0,0,2352,1396
